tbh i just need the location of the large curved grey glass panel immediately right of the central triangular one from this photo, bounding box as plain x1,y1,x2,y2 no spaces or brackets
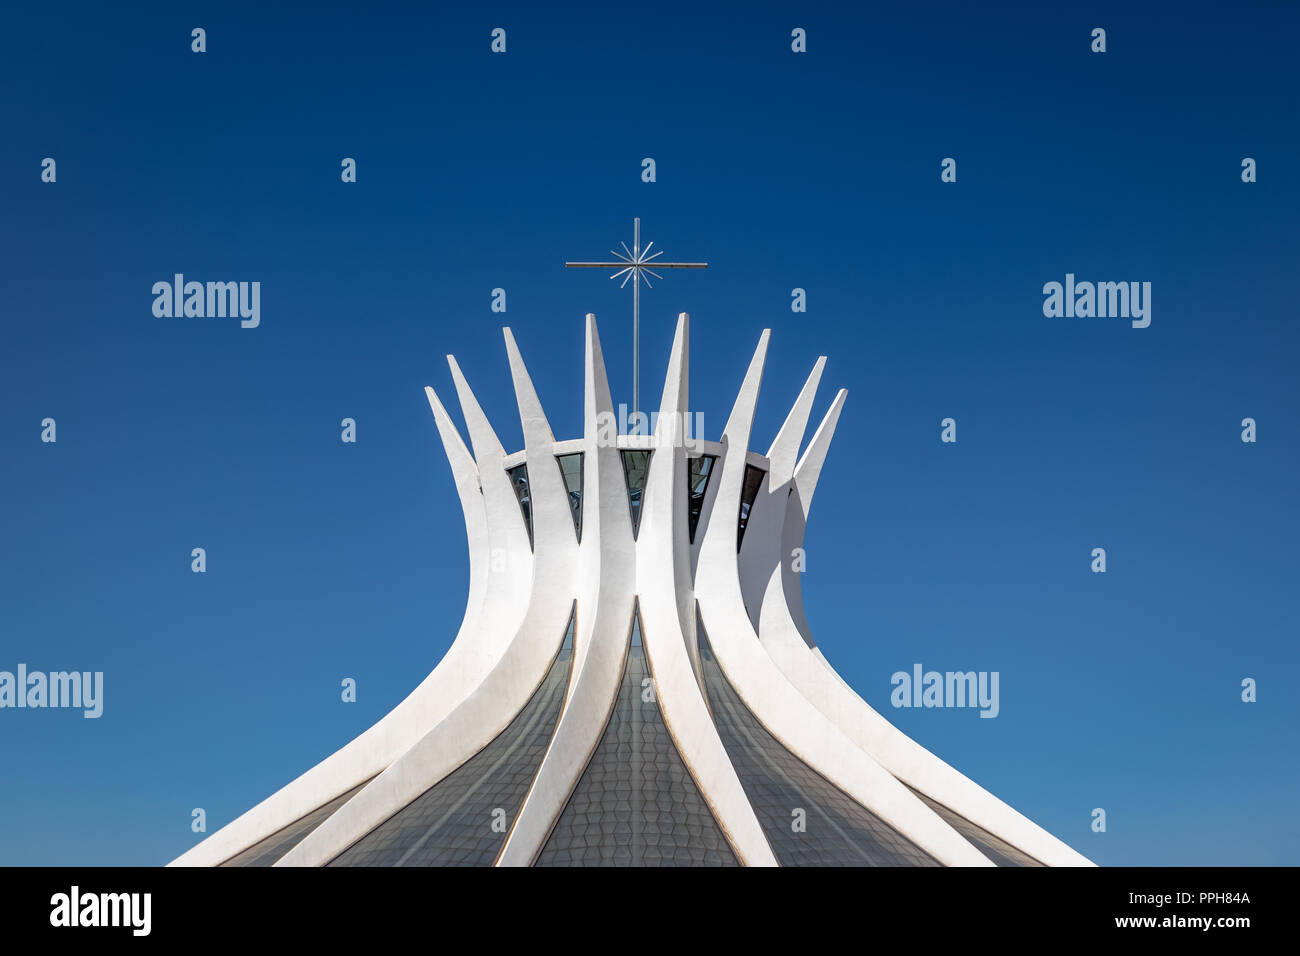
698,623,939,866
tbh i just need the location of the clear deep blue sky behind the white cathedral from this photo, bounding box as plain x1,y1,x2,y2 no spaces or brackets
0,3,1300,865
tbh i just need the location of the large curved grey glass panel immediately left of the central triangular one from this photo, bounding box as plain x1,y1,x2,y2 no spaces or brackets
329,619,573,866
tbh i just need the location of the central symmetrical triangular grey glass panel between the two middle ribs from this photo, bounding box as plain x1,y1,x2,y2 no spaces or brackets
537,613,737,866
